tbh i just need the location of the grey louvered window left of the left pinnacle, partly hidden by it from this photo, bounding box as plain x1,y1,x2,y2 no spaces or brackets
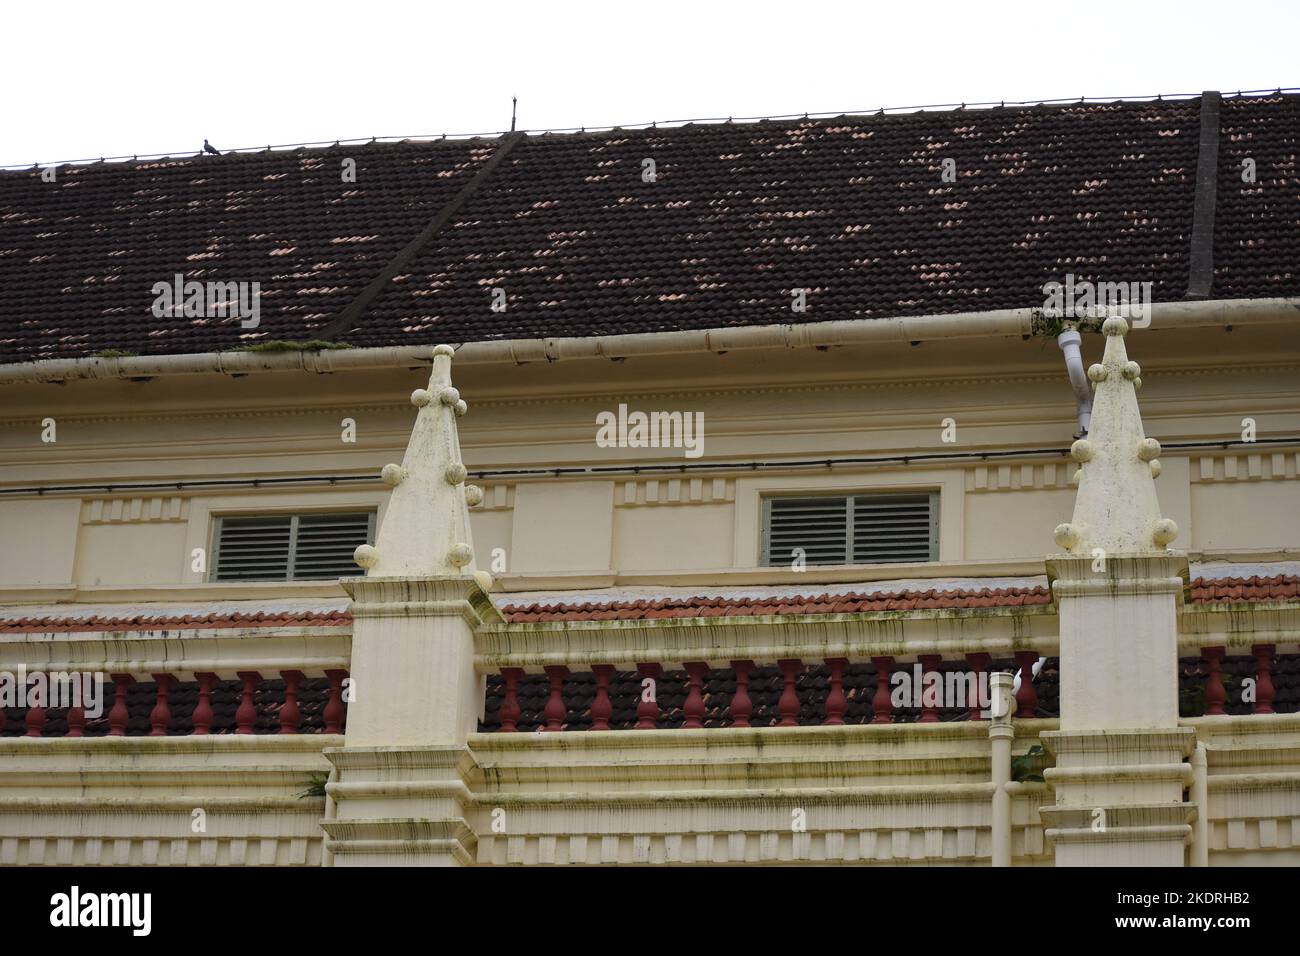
212,511,374,581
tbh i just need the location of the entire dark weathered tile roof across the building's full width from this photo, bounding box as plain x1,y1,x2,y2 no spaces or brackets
0,95,1300,362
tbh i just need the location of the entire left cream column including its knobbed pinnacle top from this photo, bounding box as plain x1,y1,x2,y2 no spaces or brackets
321,346,501,866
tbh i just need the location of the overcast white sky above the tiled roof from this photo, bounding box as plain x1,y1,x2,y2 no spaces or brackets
0,0,1300,165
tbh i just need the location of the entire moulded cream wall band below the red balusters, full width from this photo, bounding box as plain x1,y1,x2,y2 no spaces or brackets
0,714,1300,866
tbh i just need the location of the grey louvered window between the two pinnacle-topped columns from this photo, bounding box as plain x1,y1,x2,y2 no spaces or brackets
763,492,939,567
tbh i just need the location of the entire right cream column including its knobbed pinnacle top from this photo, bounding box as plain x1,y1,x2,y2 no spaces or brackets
1040,317,1196,866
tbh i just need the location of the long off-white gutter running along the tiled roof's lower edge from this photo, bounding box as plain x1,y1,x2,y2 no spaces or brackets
0,298,1300,385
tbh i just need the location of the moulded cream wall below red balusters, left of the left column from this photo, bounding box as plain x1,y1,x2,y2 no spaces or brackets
0,735,342,866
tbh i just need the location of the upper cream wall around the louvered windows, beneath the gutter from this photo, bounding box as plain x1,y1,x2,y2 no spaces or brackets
0,326,1300,601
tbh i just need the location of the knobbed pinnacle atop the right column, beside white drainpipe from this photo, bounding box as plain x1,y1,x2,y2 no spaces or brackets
1056,317,1178,557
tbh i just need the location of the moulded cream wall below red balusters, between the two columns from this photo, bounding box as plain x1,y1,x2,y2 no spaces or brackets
468,721,1054,866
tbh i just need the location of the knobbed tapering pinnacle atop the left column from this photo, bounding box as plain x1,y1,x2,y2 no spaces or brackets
355,345,477,578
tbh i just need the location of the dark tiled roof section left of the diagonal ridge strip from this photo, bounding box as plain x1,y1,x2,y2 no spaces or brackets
0,142,497,362
